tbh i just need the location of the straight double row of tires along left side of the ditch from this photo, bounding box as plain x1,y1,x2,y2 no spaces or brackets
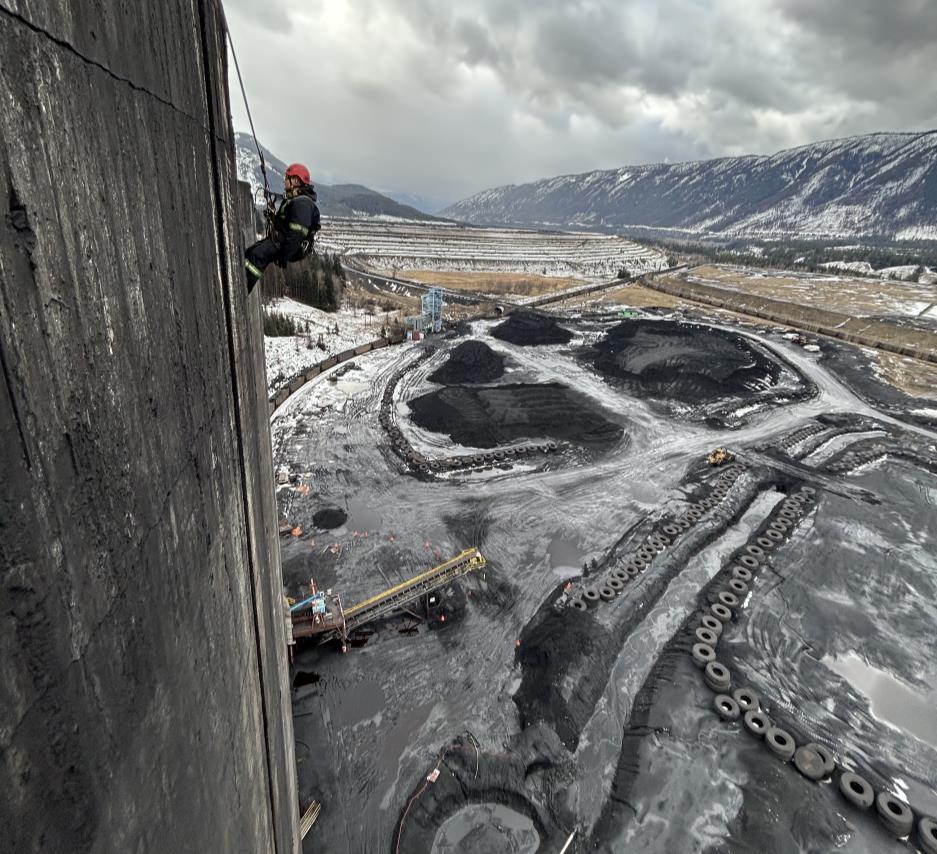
568,463,745,611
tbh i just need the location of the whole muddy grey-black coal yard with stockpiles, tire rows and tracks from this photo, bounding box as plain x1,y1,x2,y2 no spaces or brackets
272,312,937,854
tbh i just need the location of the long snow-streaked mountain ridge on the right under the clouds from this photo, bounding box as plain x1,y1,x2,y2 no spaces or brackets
440,131,937,240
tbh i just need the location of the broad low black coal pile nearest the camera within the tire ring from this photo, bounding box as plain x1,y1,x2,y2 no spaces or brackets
410,383,624,450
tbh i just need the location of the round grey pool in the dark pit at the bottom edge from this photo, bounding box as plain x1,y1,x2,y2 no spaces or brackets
432,804,540,854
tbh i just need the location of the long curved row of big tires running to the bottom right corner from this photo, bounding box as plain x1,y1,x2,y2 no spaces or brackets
690,486,937,854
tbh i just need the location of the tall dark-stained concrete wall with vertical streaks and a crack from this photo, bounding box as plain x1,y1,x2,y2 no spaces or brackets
0,0,298,854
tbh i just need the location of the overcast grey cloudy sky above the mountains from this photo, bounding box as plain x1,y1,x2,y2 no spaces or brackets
224,0,937,206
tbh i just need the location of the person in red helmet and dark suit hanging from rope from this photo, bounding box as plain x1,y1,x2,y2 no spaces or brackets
244,163,321,293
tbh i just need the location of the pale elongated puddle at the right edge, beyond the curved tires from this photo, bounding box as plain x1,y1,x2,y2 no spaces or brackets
823,652,937,747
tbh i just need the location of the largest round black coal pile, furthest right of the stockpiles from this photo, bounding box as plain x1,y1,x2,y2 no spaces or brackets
591,320,782,404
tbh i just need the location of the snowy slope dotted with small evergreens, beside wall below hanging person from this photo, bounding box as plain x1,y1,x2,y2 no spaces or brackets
264,299,383,392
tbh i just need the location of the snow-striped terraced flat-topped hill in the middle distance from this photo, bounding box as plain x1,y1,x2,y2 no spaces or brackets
317,217,667,281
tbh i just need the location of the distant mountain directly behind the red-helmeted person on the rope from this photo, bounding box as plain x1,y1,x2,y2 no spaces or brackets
234,133,437,220
